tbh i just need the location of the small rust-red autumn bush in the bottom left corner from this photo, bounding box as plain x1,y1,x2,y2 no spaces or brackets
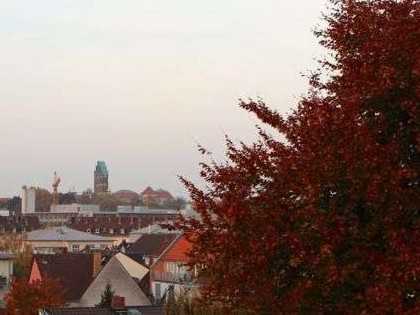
5,279,64,315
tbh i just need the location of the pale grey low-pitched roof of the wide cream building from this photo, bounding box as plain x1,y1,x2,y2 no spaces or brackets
26,226,113,242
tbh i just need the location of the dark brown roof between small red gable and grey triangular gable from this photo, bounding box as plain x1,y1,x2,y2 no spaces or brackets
34,253,94,301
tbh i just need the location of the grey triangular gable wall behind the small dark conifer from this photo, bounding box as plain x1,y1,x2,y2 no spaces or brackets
80,256,150,307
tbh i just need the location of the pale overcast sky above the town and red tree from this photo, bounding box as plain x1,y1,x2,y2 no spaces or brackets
0,0,326,196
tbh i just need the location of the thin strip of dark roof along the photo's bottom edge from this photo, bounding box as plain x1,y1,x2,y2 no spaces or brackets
47,305,165,315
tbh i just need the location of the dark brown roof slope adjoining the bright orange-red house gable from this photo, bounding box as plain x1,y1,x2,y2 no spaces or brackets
128,233,178,257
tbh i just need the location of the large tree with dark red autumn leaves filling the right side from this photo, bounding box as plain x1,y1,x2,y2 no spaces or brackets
178,0,420,314
